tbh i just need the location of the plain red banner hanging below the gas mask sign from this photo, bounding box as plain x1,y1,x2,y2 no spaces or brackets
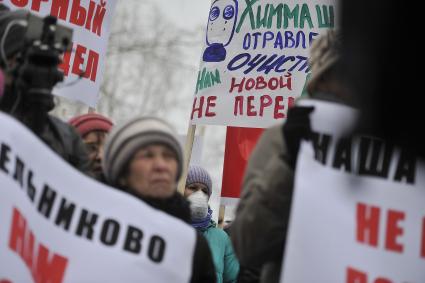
221,127,264,198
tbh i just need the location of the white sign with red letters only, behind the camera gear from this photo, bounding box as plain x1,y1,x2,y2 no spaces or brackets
1,0,117,107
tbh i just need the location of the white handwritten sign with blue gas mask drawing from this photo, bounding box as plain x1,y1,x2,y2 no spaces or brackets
191,0,338,128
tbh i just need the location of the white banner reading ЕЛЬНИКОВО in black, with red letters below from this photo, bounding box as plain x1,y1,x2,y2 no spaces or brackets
0,113,196,283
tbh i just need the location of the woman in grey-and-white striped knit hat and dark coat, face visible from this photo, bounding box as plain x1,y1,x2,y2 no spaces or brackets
102,117,216,283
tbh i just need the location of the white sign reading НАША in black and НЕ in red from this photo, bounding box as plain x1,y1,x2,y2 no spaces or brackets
281,101,425,283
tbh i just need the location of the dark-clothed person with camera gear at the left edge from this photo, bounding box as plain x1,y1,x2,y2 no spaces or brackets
0,4,89,173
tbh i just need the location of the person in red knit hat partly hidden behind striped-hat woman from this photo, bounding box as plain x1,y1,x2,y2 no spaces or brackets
69,113,113,181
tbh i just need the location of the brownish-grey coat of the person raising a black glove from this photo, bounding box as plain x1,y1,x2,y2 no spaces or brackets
230,126,294,282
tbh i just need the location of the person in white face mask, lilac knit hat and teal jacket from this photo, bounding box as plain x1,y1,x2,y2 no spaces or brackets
184,166,239,283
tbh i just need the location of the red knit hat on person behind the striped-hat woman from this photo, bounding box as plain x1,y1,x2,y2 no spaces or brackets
68,113,114,137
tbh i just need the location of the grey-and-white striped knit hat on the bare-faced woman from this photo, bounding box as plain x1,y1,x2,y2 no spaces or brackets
102,117,183,185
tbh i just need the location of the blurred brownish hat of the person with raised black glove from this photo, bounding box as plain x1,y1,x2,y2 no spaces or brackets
307,30,342,91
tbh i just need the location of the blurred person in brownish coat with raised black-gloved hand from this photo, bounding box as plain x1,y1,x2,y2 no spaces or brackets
231,30,353,283
